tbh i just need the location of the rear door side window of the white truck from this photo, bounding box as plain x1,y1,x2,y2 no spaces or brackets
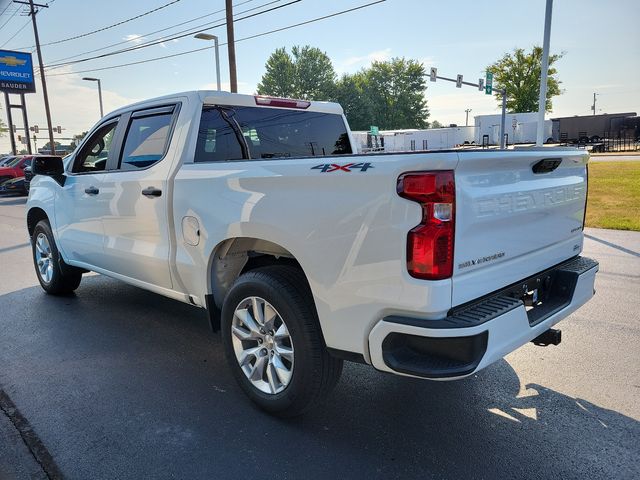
119,109,173,170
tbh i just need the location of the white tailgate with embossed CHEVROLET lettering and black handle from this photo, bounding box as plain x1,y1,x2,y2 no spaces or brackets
452,148,588,306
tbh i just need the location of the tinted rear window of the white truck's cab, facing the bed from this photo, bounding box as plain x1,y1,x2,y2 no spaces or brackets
195,107,352,162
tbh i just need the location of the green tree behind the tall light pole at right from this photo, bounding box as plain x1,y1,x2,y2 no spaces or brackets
487,45,564,112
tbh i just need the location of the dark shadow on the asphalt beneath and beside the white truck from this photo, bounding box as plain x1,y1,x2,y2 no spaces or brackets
0,275,640,479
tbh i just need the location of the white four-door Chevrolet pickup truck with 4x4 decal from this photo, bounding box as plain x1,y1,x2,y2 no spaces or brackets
27,91,598,415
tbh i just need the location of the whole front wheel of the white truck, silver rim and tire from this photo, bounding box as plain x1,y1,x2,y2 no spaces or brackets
31,220,82,295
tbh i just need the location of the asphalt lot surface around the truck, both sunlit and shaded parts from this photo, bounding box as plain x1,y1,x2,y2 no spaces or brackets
0,193,640,480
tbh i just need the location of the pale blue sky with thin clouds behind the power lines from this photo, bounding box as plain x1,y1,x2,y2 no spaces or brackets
0,0,640,152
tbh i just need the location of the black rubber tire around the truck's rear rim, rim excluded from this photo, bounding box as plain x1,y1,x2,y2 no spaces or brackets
221,265,343,417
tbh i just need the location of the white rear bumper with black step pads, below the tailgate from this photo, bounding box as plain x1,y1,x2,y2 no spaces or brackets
369,257,598,379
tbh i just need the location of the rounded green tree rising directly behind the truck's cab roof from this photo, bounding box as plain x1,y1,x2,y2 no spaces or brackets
258,45,336,100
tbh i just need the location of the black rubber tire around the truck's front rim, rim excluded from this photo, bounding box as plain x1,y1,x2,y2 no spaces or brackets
31,220,82,295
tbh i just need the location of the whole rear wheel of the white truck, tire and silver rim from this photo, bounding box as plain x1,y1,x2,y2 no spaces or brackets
222,266,342,417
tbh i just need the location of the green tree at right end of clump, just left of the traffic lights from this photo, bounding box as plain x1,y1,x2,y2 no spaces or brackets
365,58,429,130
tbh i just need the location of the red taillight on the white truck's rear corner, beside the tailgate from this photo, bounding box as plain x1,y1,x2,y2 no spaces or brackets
398,170,456,280
